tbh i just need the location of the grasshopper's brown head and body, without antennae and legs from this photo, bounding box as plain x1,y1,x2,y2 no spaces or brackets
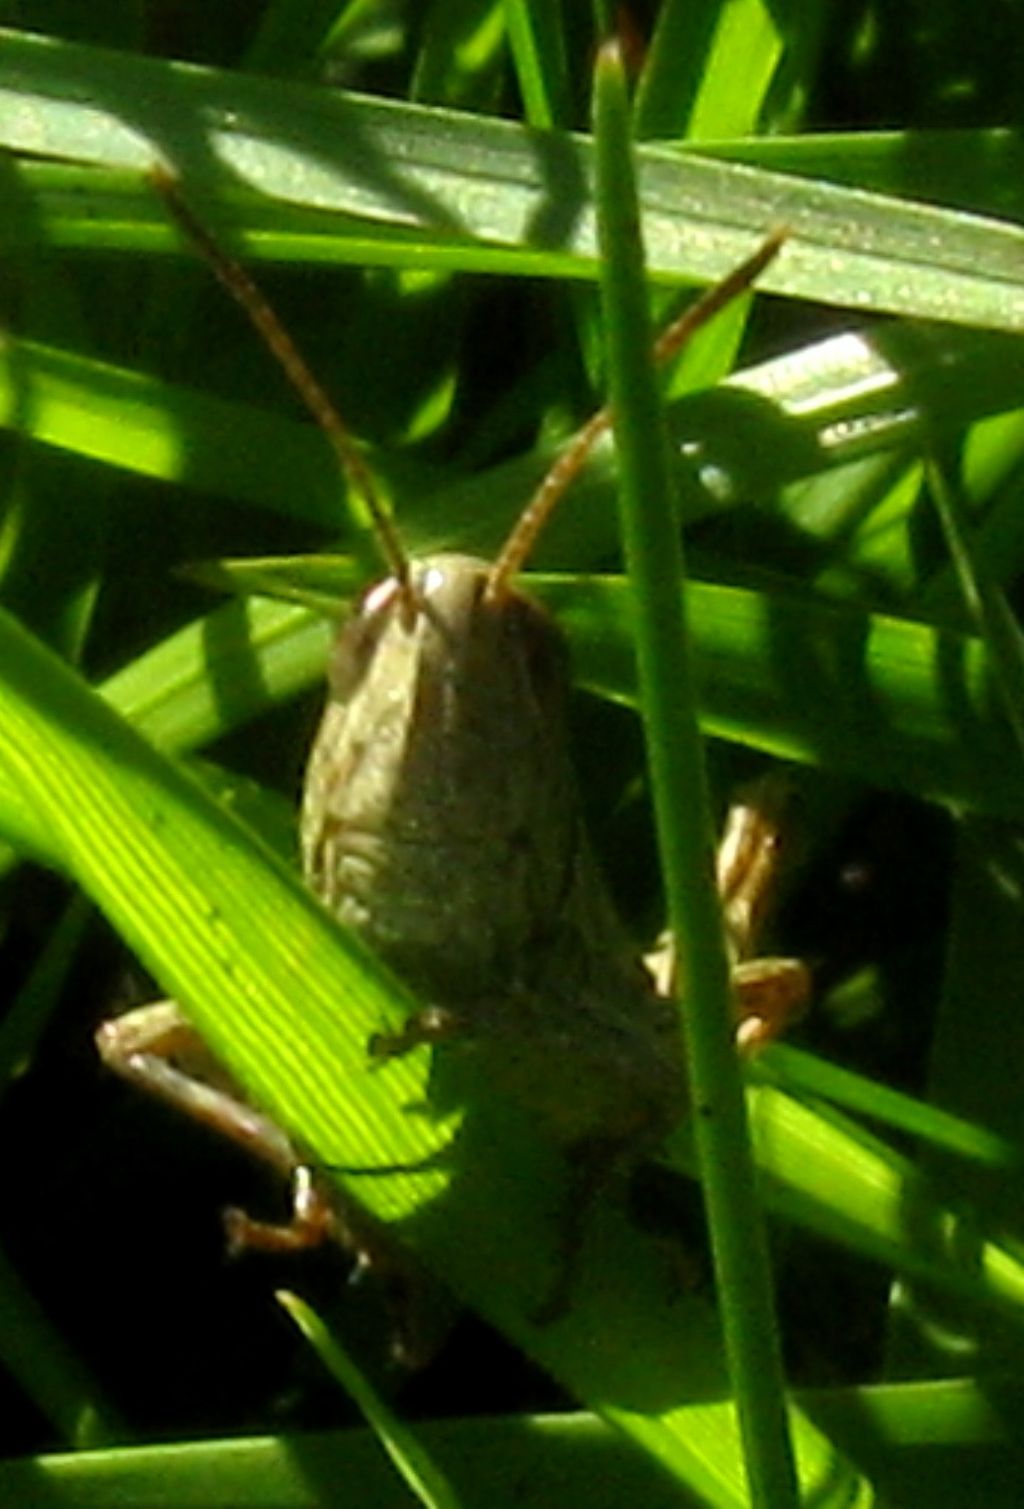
302,555,683,1144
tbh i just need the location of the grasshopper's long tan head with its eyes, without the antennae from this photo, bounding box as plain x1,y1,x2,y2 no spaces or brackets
303,555,579,999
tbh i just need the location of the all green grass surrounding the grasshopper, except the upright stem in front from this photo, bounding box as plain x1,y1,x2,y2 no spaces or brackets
0,0,1024,1504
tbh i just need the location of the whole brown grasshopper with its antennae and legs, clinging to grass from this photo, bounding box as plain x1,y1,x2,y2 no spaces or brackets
97,172,807,1346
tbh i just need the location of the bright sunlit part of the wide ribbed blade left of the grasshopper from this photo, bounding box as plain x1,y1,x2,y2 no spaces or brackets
0,594,440,1195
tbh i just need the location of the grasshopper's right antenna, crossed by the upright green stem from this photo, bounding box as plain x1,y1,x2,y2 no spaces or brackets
484,228,789,602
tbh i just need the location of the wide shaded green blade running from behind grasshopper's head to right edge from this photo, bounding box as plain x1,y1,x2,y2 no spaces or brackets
548,576,1024,816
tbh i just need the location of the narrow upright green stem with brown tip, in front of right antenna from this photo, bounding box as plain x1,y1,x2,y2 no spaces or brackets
594,35,796,1506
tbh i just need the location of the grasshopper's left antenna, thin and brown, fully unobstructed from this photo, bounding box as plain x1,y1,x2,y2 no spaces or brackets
149,164,409,593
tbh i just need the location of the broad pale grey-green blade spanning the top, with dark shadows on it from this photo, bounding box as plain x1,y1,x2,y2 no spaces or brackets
0,32,1024,330
